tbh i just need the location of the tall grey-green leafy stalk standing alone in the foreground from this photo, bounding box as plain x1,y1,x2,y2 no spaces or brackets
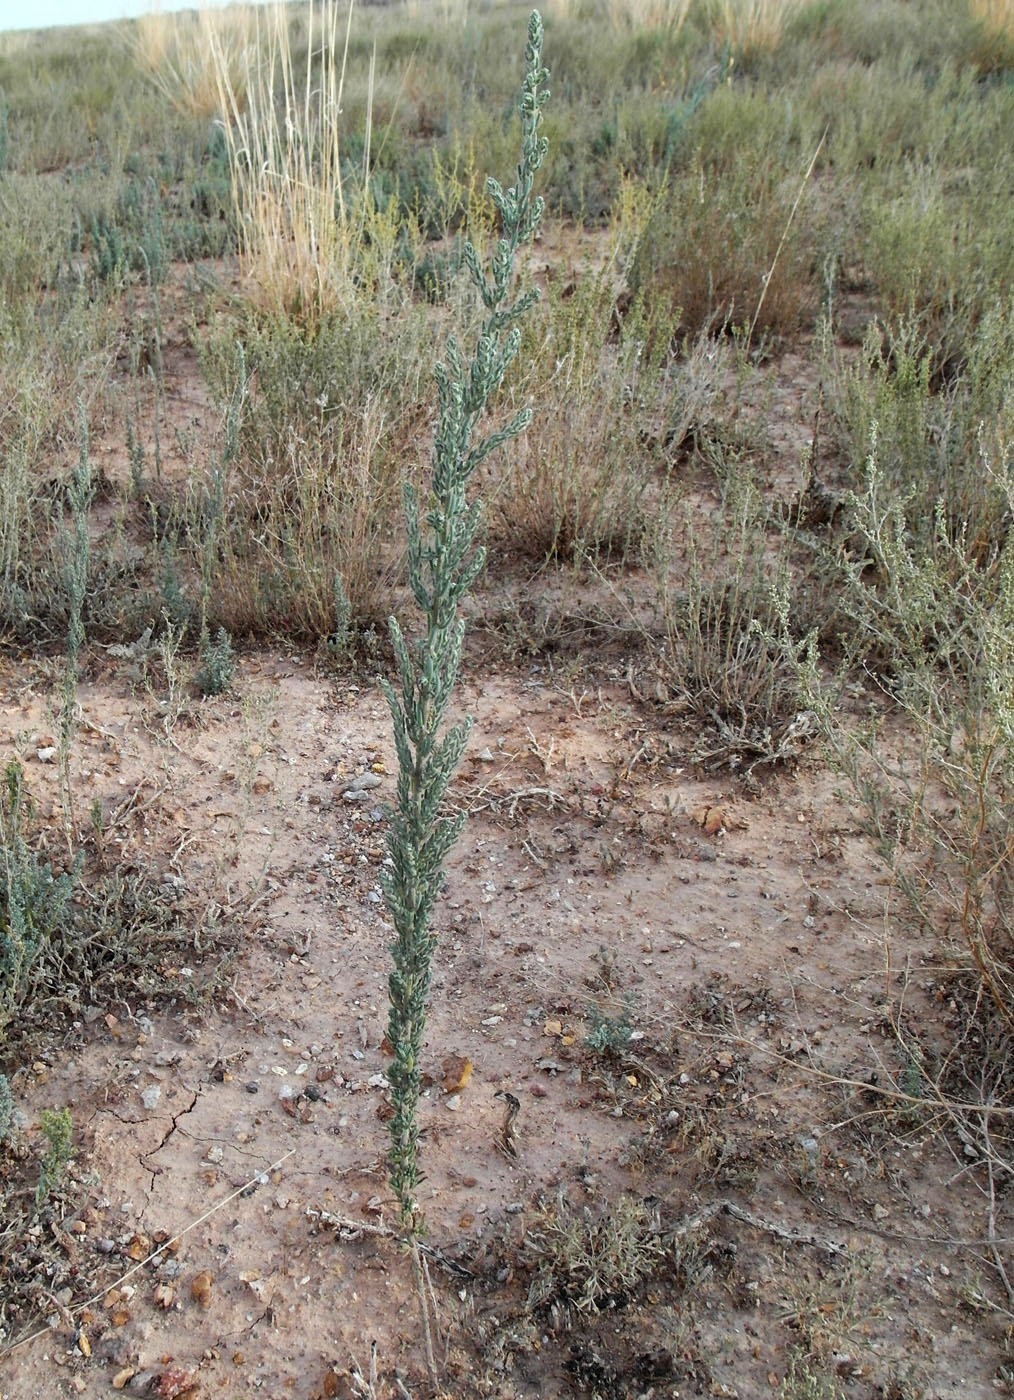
384,11,549,1240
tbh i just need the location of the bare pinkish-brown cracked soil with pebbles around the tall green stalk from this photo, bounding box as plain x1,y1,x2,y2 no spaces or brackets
0,654,1004,1400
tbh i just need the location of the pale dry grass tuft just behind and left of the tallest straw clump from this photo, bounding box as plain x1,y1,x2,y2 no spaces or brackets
123,4,256,118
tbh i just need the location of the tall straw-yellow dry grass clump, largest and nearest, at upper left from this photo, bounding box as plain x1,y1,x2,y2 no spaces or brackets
210,0,398,323
